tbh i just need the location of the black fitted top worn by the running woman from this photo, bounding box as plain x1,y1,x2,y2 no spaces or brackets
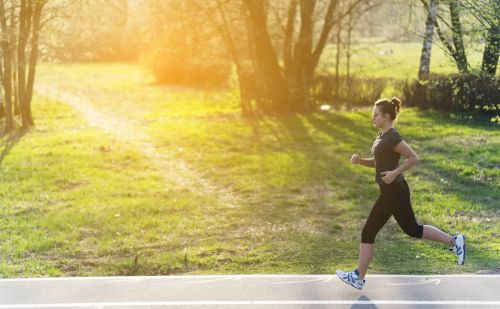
372,128,404,186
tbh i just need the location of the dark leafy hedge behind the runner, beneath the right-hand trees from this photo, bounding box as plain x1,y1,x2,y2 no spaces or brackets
403,75,500,121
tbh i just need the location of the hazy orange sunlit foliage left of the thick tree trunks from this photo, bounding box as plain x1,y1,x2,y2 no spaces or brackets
143,0,231,88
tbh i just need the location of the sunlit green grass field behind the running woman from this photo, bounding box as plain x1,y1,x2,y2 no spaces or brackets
0,60,500,277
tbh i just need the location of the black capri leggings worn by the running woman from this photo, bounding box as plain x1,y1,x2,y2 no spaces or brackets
361,179,424,244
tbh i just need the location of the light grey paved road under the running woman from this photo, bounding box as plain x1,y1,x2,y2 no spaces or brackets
0,275,500,309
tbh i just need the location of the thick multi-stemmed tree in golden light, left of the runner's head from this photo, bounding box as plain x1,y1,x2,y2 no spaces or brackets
243,0,376,112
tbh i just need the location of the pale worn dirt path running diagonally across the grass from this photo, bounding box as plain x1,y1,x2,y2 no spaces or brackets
35,85,237,208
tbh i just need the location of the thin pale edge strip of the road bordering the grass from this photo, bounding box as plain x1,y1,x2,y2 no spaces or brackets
0,274,500,283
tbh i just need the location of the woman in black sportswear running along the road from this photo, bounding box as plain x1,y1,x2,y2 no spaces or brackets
337,97,466,290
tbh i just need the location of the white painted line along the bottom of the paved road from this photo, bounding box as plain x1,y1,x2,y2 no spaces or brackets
0,300,500,309
